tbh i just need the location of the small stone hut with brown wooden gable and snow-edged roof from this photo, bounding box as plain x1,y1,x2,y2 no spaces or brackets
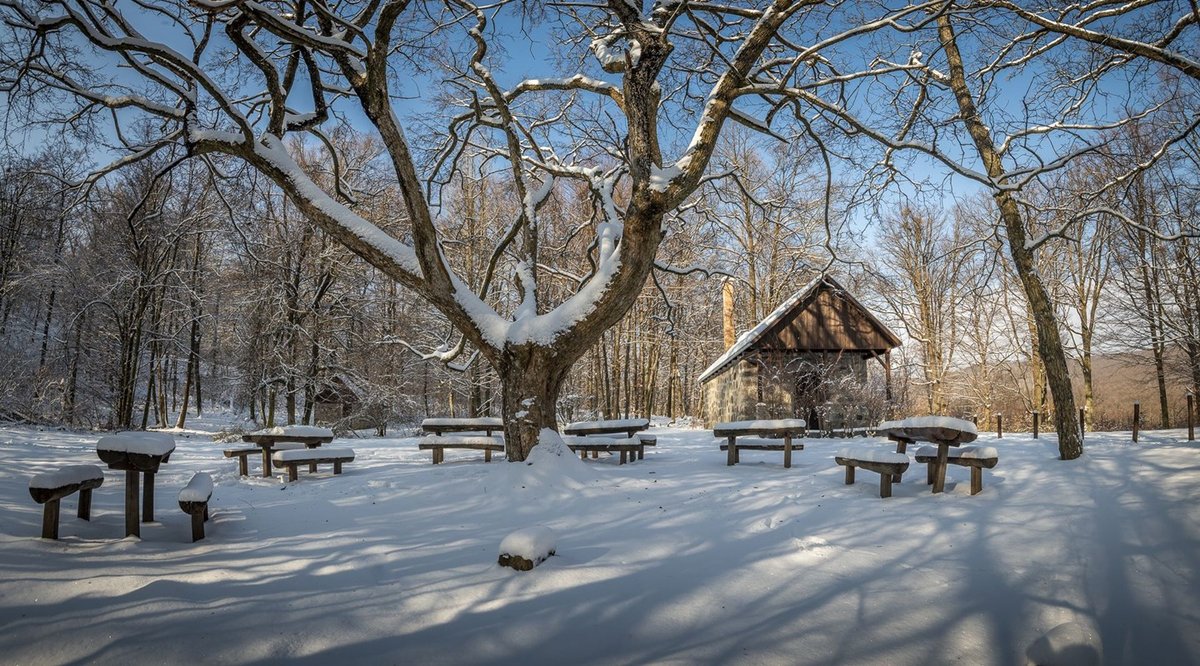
700,275,900,427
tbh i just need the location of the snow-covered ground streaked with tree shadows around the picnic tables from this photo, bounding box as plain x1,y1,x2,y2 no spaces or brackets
0,426,1200,665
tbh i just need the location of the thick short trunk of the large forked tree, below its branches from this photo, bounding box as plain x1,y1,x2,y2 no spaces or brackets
497,344,575,462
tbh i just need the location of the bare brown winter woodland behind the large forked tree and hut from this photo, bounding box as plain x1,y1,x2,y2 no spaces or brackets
0,121,1200,428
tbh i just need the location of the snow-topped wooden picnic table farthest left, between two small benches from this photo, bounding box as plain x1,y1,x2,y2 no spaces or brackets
96,432,175,536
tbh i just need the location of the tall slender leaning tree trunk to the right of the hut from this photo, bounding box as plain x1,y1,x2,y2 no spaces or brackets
937,13,1084,460
